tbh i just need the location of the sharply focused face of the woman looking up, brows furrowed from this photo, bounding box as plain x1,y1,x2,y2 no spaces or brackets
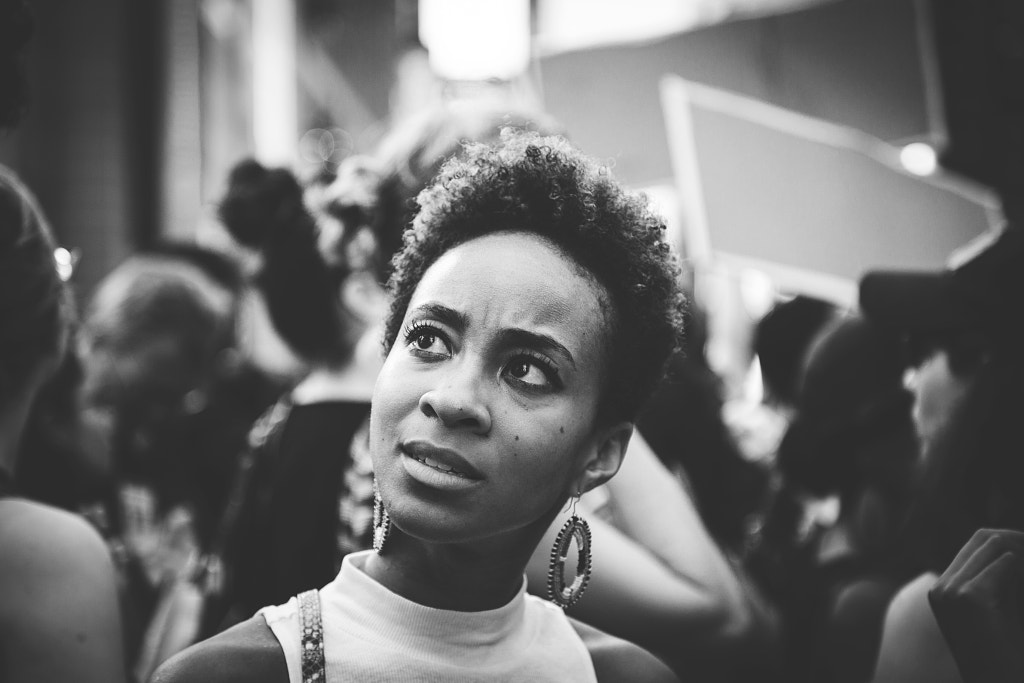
371,232,628,543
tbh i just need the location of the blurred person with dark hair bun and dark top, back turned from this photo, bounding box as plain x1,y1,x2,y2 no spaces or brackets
211,161,379,628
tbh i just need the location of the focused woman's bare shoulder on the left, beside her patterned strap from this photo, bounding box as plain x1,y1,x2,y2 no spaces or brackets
150,615,288,683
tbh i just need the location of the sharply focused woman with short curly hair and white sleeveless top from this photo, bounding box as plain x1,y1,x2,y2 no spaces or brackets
154,133,682,683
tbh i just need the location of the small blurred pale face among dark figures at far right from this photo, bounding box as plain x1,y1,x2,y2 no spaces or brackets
903,347,972,453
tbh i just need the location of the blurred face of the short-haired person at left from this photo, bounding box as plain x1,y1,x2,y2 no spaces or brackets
81,258,230,479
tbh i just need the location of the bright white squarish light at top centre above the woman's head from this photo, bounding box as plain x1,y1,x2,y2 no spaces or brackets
420,0,530,81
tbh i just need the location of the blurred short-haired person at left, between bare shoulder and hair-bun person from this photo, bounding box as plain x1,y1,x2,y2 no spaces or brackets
80,244,278,680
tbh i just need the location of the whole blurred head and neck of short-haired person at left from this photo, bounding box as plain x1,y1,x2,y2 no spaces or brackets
80,246,249,544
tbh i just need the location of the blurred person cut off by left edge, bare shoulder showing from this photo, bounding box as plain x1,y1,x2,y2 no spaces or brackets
0,0,125,683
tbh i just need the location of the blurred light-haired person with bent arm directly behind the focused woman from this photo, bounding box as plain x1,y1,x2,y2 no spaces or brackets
327,102,777,681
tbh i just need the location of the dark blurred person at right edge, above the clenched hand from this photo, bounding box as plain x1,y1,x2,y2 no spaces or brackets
860,225,1024,683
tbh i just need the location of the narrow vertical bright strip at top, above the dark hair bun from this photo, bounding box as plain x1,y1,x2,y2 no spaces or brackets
252,0,299,166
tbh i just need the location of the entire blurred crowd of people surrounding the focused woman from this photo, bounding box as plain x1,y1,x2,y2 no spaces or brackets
0,3,1024,683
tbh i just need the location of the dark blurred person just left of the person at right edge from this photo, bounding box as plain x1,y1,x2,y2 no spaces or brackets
754,316,918,683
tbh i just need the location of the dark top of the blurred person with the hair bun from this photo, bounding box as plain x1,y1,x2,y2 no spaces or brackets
221,398,372,626
